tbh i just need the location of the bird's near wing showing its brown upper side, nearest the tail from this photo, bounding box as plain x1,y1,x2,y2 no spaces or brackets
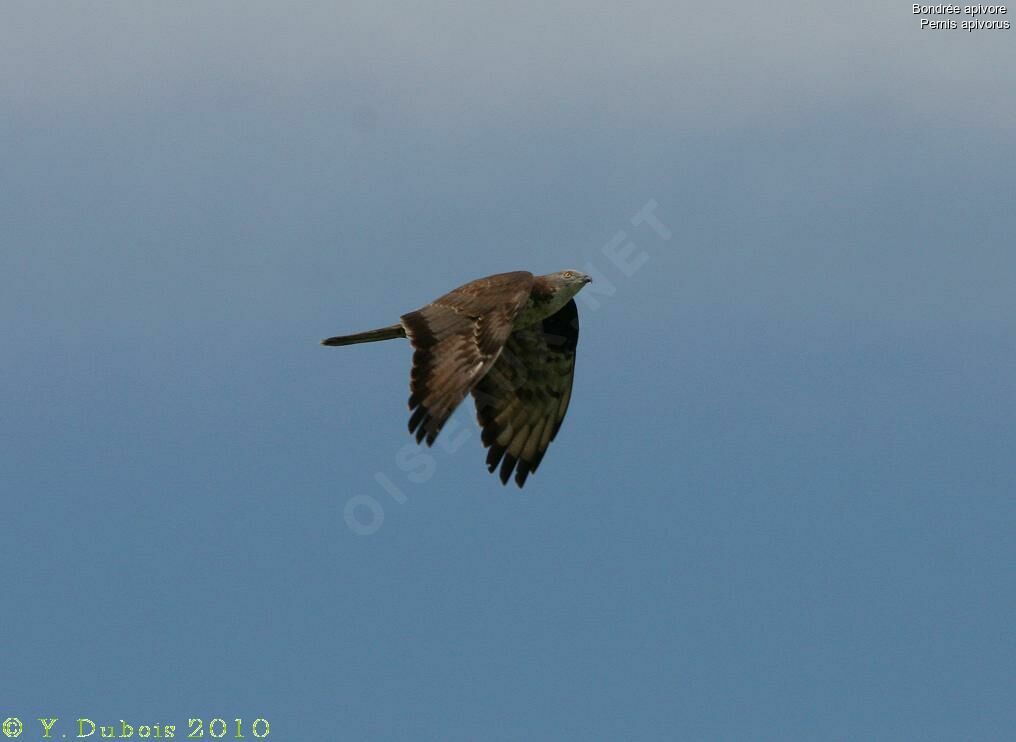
401,270,533,445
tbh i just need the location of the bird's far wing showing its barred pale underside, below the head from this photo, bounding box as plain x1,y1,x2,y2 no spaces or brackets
472,300,578,487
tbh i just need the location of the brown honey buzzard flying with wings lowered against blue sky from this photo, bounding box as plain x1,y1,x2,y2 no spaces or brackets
321,270,592,487
